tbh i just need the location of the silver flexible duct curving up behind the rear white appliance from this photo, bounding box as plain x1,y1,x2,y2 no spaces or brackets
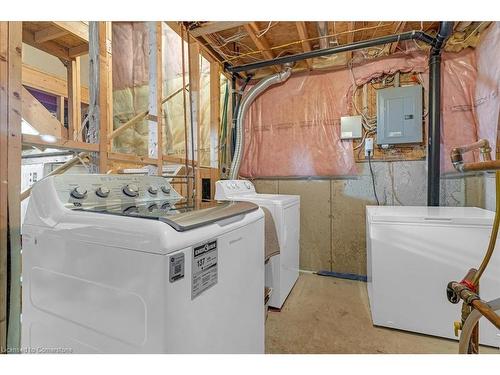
229,64,292,180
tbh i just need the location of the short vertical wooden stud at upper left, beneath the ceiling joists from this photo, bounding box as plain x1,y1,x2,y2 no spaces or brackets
66,57,82,141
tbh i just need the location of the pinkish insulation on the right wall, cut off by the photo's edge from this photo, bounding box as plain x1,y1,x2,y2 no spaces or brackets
475,22,500,154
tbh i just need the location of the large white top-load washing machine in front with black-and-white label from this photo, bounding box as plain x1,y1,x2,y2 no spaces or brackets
22,175,264,353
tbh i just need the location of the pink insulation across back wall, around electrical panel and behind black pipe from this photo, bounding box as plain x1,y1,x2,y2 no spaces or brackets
240,49,477,178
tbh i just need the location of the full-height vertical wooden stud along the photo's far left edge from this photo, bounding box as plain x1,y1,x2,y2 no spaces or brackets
0,22,22,348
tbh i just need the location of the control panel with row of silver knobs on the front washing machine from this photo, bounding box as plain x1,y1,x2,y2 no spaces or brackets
54,174,181,206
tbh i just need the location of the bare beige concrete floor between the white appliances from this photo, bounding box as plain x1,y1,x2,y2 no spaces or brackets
266,273,500,354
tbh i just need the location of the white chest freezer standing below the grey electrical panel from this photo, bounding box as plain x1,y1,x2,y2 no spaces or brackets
366,206,500,348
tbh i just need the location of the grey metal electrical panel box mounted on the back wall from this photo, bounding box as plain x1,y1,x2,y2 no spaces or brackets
377,85,423,145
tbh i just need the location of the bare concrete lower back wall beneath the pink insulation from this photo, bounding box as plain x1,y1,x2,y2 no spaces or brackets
254,161,486,275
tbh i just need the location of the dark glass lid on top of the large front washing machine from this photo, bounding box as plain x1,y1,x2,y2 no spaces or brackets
72,199,259,232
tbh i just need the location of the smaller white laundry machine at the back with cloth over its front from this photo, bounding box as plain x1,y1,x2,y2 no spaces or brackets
215,180,300,309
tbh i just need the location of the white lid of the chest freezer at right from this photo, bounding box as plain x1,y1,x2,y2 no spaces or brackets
366,206,495,226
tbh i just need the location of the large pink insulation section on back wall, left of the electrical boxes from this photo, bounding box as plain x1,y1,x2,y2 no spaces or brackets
240,70,356,177
